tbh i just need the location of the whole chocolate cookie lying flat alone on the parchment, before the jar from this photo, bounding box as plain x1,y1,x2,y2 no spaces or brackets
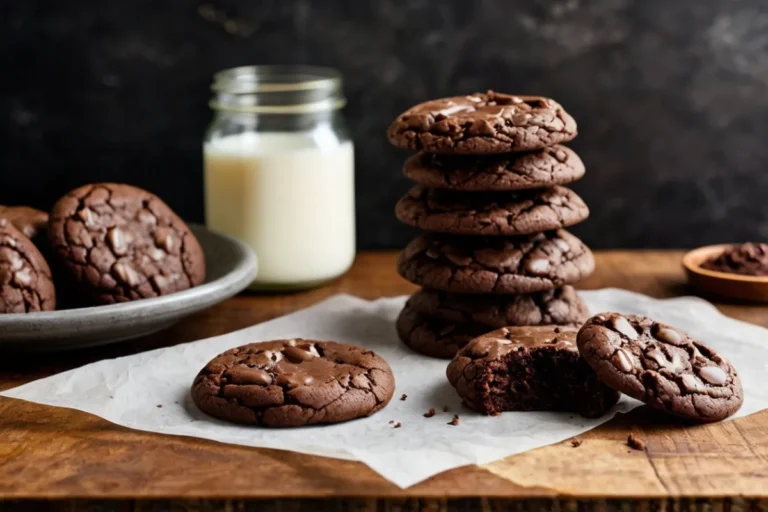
192,339,395,427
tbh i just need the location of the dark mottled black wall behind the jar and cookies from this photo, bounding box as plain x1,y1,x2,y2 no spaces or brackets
0,0,768,248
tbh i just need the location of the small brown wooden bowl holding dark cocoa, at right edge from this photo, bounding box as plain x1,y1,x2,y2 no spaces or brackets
683,244,768,302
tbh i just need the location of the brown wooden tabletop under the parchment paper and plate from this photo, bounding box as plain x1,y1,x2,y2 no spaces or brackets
0,251,768,511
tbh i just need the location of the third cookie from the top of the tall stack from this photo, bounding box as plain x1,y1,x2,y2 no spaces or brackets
395,185,589,236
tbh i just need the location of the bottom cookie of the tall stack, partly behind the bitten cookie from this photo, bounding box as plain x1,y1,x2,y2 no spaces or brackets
395,304,488,359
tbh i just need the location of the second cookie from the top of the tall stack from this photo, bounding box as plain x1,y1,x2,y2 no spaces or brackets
403,145,585,192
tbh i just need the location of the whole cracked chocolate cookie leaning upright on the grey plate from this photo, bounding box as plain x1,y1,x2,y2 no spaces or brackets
48,183,205,303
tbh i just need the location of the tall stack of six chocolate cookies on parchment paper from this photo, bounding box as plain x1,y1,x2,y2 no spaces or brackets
388,91,594,358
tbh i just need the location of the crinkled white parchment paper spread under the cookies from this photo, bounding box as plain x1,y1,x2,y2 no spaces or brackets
0,289,768,487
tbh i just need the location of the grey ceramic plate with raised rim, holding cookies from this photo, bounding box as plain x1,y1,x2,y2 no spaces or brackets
0,225,257,352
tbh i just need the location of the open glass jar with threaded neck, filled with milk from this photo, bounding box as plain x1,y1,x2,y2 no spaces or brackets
203,66,355,290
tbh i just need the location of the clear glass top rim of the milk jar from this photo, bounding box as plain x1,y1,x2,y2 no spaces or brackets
211,65,342,94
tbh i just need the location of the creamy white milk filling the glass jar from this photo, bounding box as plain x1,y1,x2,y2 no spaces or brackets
204,132,355,288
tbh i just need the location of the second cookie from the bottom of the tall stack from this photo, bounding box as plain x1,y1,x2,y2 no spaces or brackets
408,285,589,329
